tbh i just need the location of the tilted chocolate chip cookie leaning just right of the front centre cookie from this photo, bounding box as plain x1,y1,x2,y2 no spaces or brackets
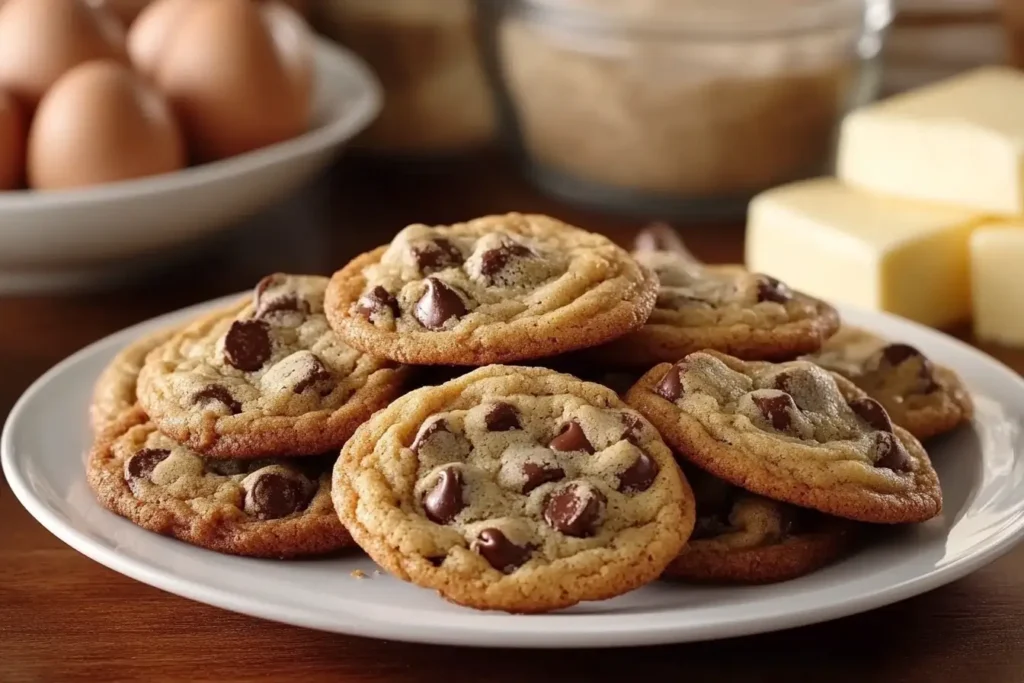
627,351,942,523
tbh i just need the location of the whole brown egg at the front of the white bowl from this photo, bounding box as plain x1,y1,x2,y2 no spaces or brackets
28,60,185,189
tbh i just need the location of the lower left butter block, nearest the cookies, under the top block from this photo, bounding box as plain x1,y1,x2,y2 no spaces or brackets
746,178,982,327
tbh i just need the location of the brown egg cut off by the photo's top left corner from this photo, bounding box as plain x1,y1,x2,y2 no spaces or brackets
0,0,127,109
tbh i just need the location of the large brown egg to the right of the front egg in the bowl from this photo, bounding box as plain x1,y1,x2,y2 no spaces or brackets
155,0,311,161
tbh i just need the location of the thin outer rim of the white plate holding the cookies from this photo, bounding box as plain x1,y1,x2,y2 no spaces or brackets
0,292,1024,649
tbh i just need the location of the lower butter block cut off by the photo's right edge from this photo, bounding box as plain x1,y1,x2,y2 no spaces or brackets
970,223,1024,346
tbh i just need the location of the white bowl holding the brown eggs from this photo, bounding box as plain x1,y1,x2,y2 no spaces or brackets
0,39,383,292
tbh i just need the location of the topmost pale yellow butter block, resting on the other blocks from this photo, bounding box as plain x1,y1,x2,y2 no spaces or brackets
837,67,1024,214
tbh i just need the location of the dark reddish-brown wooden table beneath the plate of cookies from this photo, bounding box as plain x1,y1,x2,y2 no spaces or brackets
0,152,1024,683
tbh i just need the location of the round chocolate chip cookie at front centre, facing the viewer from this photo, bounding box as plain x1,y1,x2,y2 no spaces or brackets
334,366,694,612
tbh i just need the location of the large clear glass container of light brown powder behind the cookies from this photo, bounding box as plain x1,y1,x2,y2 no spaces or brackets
481,0,891,219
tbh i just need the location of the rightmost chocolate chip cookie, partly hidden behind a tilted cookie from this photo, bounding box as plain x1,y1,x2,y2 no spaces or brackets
807,326,974,439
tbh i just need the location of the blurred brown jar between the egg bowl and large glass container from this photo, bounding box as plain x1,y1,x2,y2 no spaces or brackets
309,0,497,157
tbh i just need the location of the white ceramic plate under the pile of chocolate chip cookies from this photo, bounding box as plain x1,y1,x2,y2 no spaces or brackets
6,299,1024,647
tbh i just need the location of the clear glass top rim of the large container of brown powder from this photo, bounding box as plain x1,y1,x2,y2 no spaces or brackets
511,0,893,38
